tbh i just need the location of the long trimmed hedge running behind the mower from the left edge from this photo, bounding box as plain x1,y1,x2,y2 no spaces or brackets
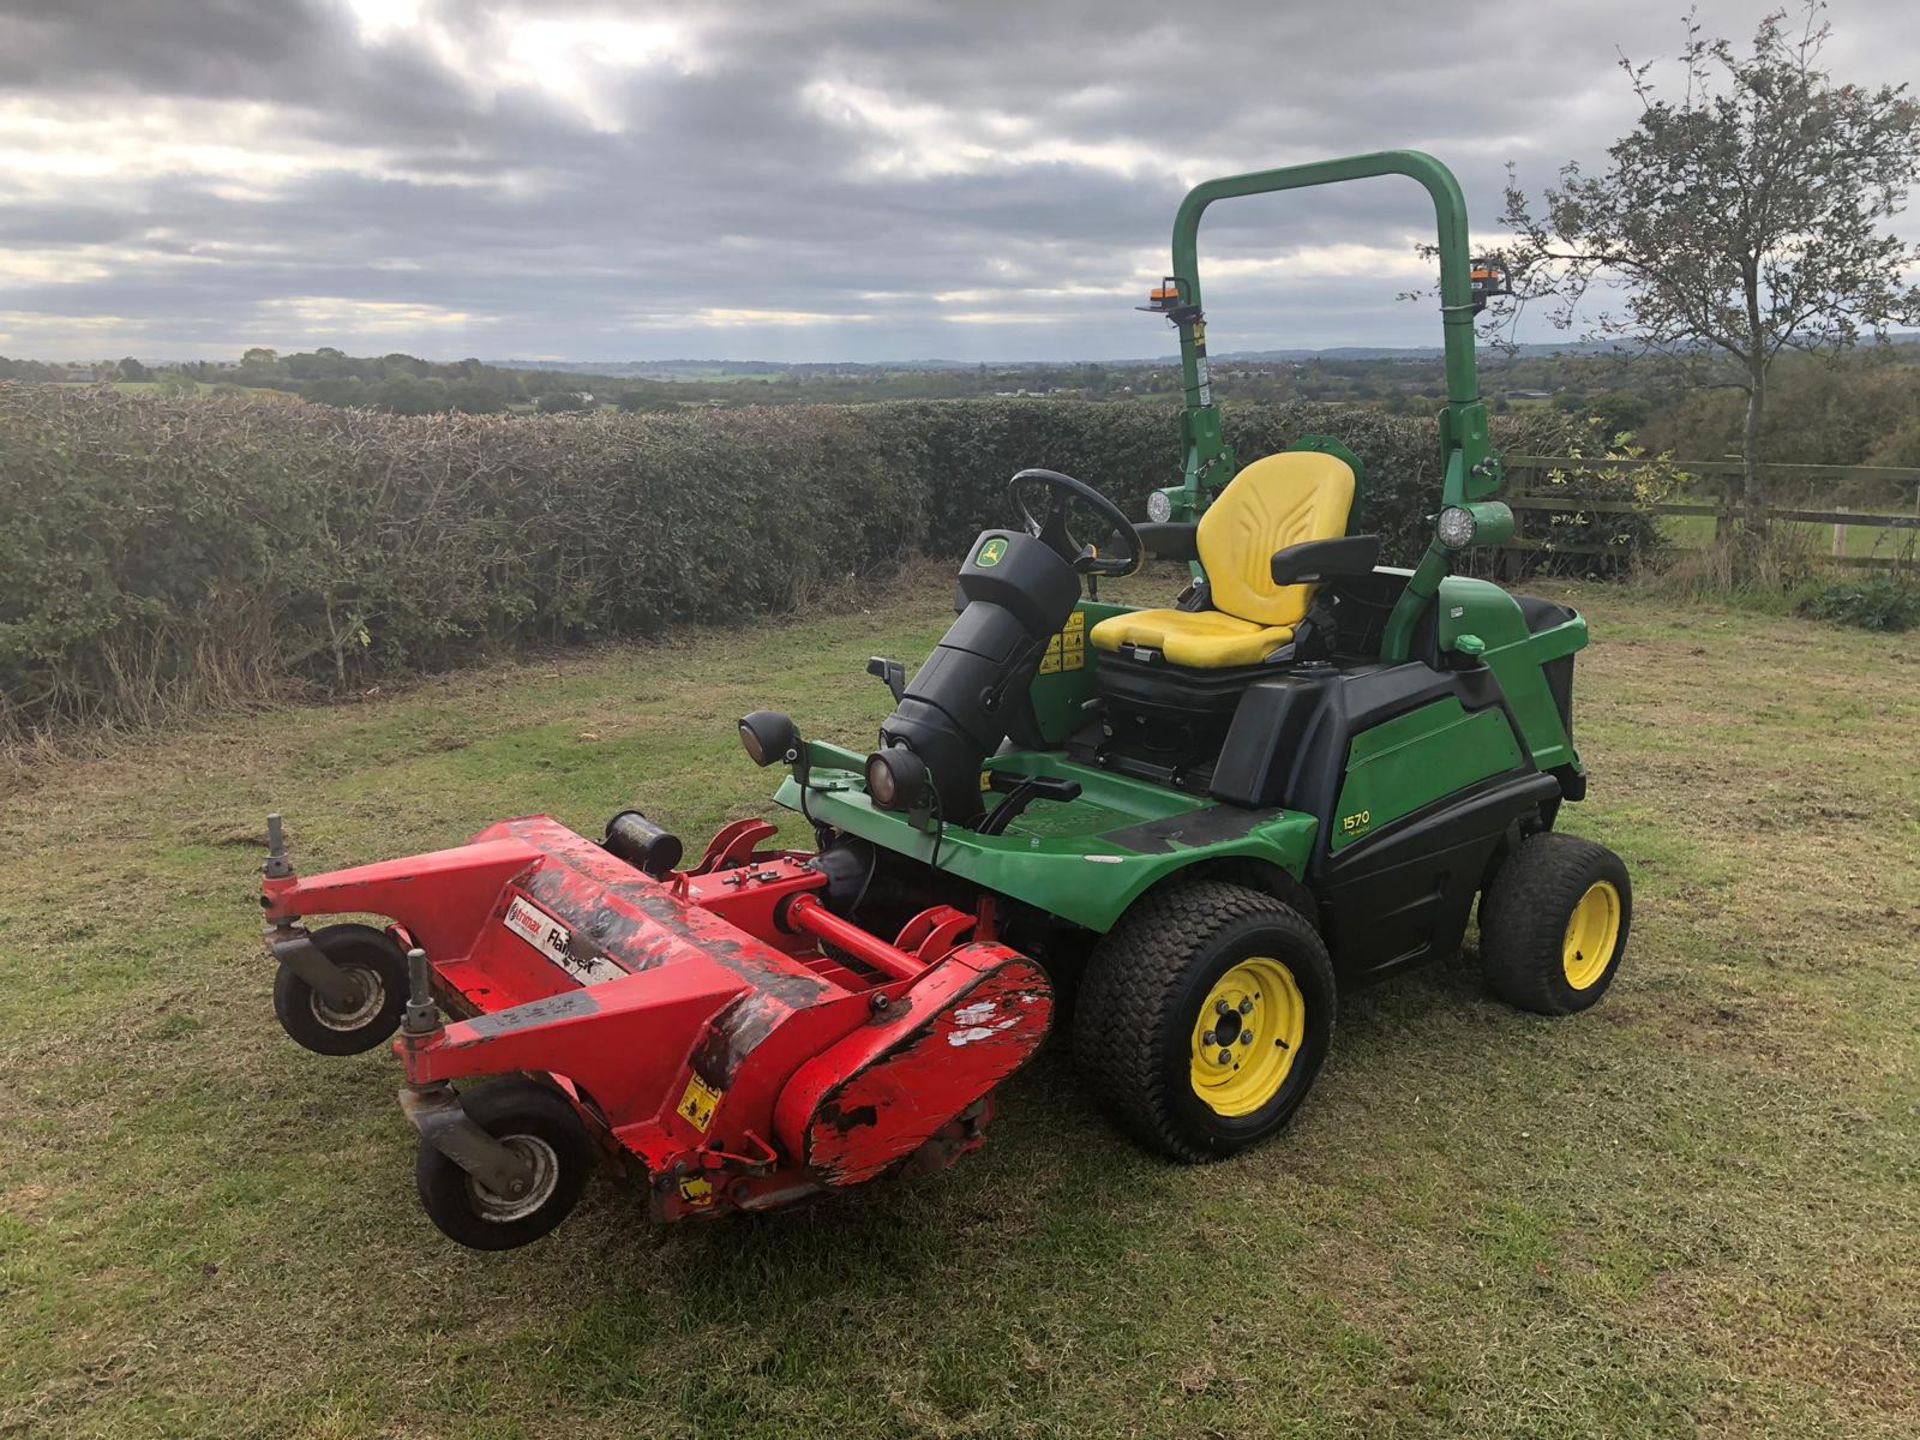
0,384,1651,737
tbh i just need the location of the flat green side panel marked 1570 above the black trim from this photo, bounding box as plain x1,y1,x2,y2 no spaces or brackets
1329,695,1523,851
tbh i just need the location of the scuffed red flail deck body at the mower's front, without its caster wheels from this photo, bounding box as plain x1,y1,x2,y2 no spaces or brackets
263,816,1052,1219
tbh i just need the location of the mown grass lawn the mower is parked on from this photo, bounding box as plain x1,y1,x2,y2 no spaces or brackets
0,580,1920,1440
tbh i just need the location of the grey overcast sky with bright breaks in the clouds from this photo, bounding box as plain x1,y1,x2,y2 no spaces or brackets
0,0,1920,359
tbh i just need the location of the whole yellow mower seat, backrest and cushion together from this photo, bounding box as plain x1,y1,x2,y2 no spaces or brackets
1089,449,1354,670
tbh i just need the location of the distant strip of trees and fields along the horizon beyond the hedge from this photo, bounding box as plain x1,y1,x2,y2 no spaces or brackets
0,344,1920,453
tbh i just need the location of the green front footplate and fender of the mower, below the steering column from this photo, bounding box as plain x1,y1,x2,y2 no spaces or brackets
774,741,1319,933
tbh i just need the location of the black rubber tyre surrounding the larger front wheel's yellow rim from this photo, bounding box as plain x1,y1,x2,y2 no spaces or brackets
1073,881,1338,1164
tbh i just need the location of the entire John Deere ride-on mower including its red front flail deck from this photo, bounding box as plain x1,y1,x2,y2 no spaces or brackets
263,152,1632,1250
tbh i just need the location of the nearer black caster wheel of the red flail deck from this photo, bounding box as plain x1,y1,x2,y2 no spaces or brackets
413,1079,593,1250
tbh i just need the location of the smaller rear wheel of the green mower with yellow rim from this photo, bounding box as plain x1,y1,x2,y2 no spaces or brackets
1480,831,1634,1016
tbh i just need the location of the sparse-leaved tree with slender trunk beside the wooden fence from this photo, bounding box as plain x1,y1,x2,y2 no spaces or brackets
1501,0,1920,576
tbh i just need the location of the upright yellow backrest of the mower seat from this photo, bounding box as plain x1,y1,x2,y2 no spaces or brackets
1196,449,1354,626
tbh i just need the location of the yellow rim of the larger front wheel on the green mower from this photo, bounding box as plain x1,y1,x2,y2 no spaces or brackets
1192,956,1308,1116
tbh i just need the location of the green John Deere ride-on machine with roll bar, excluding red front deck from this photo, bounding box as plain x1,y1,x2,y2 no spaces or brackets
743,152,1632,1162
